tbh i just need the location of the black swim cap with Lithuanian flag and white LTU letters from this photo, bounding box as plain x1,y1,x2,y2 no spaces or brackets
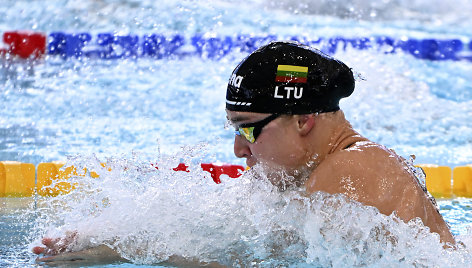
226,42,354,114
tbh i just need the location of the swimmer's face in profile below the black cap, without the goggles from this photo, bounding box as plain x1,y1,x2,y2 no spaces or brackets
226,110,306,183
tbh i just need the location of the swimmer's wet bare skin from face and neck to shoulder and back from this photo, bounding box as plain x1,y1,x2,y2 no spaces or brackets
227,111,455,244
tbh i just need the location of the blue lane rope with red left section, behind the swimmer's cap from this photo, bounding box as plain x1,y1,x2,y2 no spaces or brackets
0,31,472,61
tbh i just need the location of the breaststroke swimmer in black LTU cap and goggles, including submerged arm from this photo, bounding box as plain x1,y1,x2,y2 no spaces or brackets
33,42,455,266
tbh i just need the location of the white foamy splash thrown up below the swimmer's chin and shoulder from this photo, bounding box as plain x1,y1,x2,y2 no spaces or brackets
32,146,472,267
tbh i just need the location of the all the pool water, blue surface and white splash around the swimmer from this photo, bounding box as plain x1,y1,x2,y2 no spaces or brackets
0,0,472,267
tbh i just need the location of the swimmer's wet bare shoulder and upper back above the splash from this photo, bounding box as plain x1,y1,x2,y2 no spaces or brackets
305,141,454,243
